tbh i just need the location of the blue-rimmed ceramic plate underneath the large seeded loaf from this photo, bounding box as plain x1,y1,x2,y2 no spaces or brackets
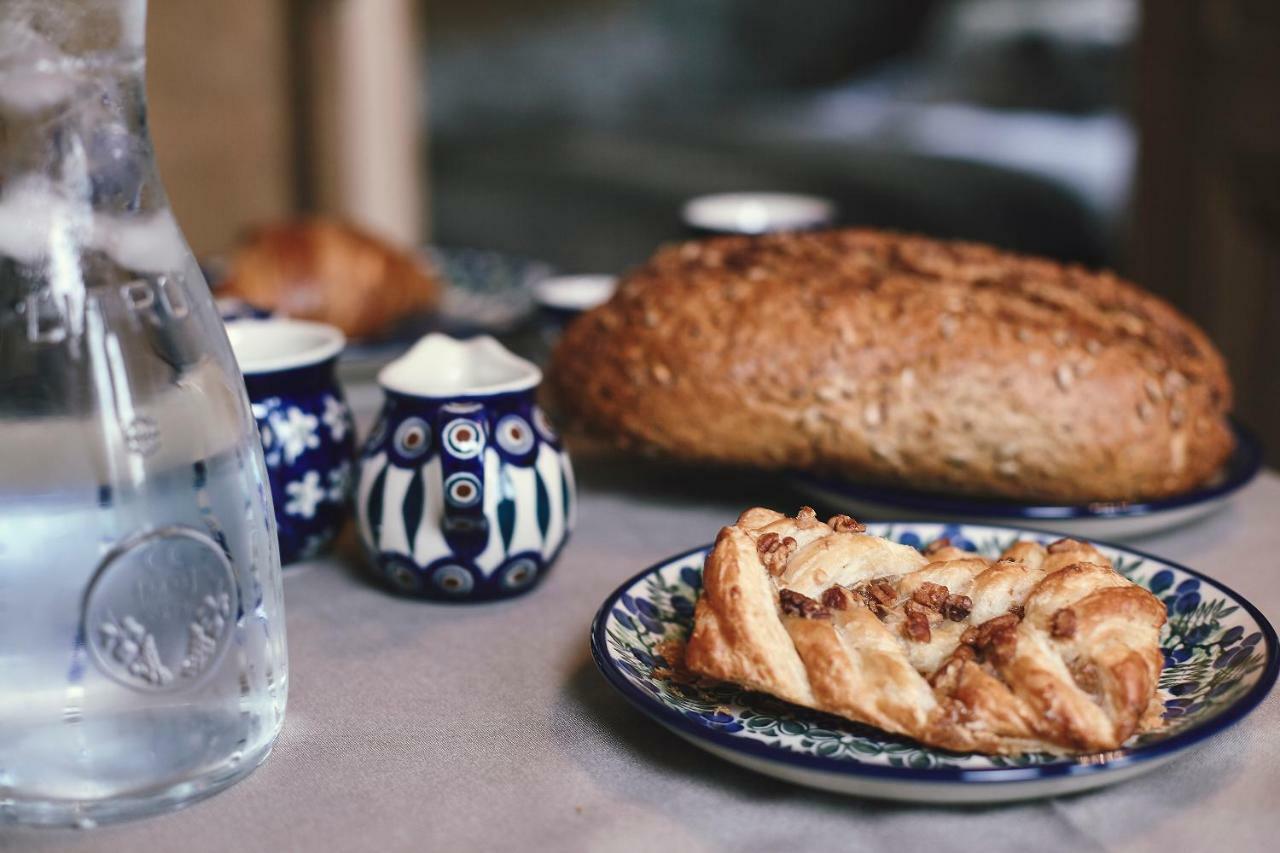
791,421,1263,539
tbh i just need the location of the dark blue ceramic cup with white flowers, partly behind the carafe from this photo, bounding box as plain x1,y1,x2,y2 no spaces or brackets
227,318,356,564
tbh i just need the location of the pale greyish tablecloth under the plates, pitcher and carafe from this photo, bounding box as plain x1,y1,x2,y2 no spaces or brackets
0,394,1280,853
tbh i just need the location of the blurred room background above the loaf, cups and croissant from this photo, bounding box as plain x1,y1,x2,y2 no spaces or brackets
148,0,1280,464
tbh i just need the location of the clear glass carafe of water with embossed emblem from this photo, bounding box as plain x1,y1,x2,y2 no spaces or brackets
0,0,288,825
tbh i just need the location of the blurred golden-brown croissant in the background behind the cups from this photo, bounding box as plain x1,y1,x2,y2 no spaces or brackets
220,220,443,338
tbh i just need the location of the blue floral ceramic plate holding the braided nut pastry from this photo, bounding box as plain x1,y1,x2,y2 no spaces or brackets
591,523,1280,803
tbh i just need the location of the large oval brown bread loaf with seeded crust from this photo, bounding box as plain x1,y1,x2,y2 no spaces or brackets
550,229,1233,502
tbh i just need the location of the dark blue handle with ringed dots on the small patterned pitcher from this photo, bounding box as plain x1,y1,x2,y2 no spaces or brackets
436,402,489,551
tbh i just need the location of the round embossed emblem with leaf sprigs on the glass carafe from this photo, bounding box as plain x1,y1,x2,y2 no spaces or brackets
82,526,239,692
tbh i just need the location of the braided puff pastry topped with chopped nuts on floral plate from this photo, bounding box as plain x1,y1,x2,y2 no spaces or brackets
685,507,1165,753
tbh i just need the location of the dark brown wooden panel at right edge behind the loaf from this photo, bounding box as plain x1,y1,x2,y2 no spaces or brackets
1132,0,1280,465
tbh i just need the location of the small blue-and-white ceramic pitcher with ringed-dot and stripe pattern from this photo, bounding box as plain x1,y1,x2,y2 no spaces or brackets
356,334,575,601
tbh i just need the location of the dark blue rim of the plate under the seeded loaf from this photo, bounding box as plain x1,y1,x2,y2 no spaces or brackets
791,418,1265,524
